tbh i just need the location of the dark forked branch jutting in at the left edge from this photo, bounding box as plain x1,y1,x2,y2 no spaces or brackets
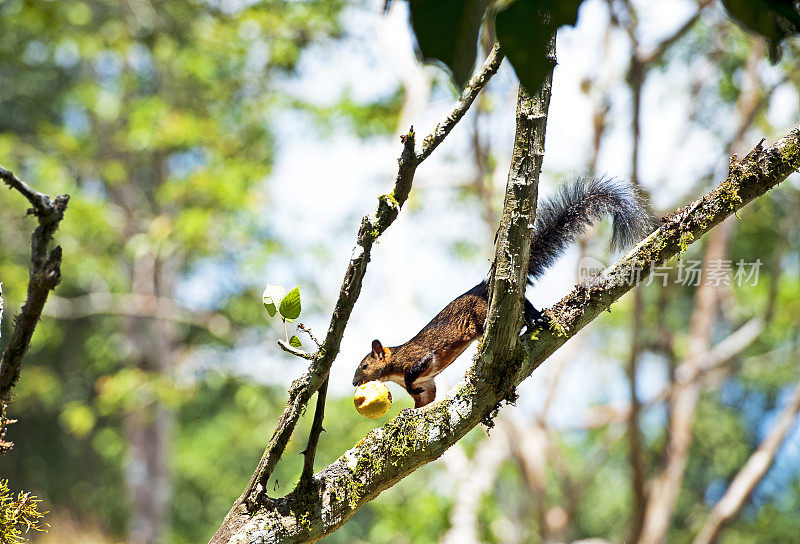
0,166,69,401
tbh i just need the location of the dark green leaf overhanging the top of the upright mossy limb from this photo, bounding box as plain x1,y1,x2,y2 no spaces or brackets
495,0,583,93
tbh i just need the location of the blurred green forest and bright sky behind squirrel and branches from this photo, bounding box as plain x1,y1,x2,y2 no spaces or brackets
0,0,800,544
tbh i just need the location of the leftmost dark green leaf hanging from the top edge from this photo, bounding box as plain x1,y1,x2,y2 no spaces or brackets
408,0,489,88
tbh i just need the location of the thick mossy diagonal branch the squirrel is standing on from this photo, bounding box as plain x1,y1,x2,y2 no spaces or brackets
212,129,800,542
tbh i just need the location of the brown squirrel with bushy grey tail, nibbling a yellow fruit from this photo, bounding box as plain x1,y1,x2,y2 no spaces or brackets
353,178,654,408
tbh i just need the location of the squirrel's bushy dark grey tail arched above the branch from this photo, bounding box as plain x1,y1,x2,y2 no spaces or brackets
528,178,655,281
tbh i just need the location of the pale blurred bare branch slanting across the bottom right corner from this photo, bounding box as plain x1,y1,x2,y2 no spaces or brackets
693,376,800,544
